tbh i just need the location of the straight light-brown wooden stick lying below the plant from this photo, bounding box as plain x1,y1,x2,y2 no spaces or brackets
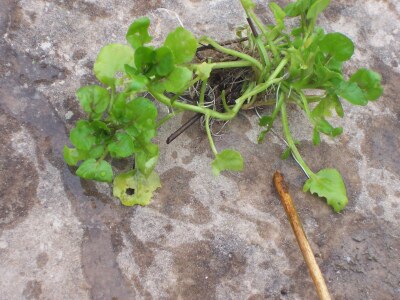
274,171,331,300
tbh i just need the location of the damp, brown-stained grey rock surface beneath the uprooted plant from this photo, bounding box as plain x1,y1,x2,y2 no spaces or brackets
0,0,400,300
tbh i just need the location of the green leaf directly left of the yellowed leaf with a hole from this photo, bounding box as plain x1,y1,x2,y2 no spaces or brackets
76,158,113,182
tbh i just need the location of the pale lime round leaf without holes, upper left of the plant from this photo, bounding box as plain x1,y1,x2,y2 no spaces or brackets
94,44,134,86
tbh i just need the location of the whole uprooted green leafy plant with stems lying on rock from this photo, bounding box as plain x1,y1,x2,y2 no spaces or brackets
64,0,382,212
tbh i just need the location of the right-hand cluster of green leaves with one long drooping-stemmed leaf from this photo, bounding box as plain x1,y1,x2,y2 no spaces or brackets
250,0,383,212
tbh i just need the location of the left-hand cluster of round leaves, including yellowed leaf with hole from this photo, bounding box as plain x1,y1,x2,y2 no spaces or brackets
64,18,202,206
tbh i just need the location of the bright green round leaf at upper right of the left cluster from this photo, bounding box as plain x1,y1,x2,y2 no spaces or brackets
164,27,197,64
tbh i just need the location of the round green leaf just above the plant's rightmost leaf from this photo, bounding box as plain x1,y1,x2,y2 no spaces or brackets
319,32,354,61
